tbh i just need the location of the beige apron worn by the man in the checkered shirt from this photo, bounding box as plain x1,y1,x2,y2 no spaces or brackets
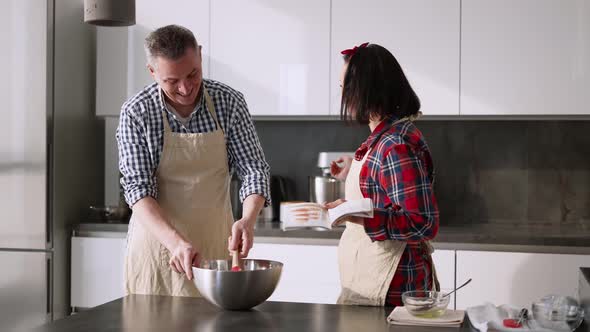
125,87,233,296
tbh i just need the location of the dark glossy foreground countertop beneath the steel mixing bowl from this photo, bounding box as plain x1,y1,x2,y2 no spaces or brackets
35,295,471,332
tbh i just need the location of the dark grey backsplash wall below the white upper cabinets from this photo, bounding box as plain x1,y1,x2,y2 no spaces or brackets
256,120,590,226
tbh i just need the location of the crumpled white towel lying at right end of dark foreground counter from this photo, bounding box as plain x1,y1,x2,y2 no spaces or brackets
467,303,551,332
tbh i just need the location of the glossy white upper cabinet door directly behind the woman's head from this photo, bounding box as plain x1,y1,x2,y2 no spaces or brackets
330,0,460,115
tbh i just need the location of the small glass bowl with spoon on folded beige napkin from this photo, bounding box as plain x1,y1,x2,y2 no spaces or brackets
402,291,451,318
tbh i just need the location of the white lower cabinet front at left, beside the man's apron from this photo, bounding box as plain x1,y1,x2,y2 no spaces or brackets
71,237,126,308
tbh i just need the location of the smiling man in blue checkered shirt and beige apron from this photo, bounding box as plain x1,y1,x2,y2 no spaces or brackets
117,25,270,296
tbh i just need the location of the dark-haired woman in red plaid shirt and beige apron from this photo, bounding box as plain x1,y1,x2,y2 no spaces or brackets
326,43,439,306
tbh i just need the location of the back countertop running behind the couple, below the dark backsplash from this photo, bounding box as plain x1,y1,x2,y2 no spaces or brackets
74,221,590,254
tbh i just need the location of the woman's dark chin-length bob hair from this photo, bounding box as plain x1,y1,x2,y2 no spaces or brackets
340,44,420,124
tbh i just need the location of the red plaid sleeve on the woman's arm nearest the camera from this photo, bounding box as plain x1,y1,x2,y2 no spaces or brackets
365,144,439,242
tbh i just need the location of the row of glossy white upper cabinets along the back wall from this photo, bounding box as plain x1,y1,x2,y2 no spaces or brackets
96,0,590,118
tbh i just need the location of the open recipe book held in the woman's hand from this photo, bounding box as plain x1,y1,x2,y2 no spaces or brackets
280,198,373,230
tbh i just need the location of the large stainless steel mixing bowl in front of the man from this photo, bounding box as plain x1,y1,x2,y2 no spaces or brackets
193,259,283,310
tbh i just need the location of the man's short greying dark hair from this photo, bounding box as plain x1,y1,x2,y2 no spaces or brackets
144,25,199,66
